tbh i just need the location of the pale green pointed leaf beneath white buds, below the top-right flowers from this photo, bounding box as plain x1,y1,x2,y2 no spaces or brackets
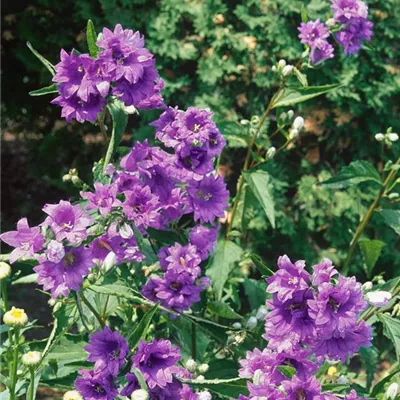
272,84,341,108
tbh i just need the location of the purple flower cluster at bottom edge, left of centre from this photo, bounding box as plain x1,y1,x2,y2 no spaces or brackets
75,327,199,400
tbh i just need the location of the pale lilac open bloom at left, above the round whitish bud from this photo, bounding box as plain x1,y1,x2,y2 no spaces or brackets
43,200,93,245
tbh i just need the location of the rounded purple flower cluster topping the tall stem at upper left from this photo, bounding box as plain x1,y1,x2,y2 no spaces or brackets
52,24,164,122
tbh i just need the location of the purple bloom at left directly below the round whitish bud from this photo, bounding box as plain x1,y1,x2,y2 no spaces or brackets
34,246,93,298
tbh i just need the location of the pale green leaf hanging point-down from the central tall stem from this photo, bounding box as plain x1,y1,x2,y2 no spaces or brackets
244,170,275,229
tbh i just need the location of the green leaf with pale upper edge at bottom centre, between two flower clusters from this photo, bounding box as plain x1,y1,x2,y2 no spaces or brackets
183,378,249,398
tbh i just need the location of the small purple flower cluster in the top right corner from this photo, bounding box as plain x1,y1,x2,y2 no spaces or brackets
298,0,373,65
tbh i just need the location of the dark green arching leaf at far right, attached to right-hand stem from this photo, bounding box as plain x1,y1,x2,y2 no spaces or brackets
318,160,382,189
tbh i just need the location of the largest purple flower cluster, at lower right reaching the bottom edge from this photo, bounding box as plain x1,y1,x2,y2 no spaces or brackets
239,256,371,400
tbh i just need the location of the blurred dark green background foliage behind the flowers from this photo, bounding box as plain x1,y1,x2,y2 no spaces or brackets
0,0,400,278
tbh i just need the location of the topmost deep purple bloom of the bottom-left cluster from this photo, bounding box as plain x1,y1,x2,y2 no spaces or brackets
85,326,129,376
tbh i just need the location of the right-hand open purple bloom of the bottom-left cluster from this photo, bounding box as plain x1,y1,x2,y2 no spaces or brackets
132,339,181,389
